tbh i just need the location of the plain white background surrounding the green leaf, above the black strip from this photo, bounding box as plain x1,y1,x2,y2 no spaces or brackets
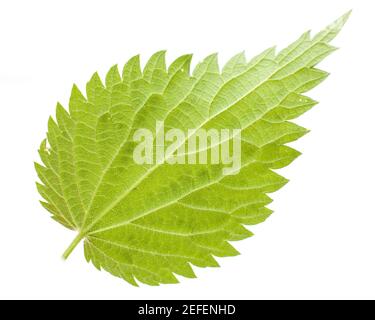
0,0,375,299
